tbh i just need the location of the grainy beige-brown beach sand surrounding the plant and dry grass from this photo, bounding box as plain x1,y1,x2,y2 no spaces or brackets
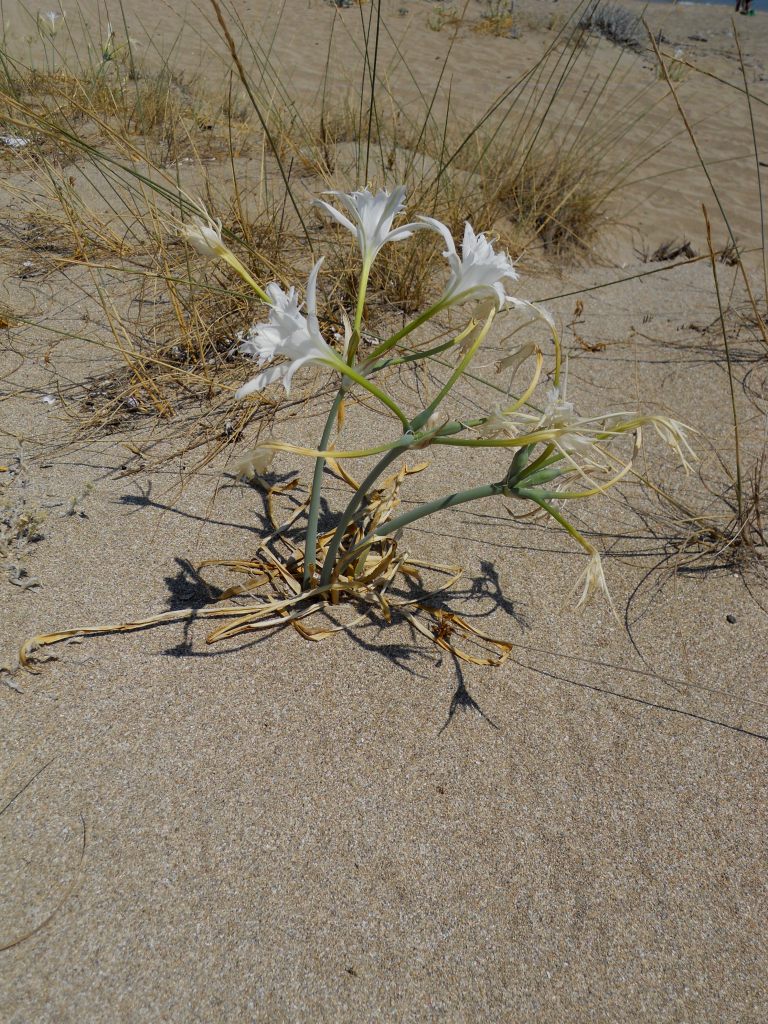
0,0,768,1024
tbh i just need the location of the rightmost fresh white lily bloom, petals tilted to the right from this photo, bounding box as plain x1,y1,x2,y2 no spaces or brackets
419,217,517,309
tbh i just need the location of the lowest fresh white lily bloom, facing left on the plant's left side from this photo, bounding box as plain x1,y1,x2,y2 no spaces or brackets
234,259,343,398
